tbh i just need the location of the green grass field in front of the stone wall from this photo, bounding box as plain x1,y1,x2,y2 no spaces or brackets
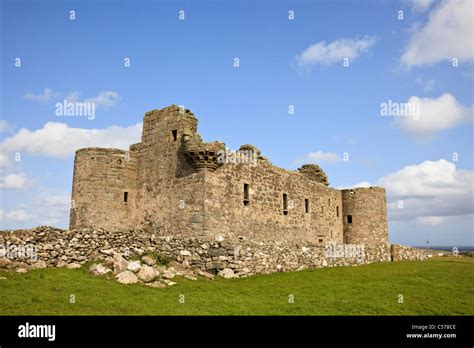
0,257,474,315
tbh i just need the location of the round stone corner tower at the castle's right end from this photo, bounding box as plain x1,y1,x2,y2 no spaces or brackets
341,187,388,244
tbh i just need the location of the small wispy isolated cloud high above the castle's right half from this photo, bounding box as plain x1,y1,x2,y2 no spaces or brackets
296,36,376,69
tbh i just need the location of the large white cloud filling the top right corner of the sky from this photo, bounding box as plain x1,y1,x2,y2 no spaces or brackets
401,0,474,67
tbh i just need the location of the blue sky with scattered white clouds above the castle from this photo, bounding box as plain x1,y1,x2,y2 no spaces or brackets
0,0,474,245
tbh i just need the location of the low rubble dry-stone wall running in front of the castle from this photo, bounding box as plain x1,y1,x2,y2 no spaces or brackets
0,227,426,276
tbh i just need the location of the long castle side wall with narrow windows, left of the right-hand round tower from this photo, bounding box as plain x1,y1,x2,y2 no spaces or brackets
205,160,343,244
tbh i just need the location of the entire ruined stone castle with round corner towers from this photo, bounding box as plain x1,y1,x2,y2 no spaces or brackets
70,105,388,244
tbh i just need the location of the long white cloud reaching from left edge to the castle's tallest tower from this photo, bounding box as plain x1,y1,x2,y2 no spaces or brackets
0,122,142,158
